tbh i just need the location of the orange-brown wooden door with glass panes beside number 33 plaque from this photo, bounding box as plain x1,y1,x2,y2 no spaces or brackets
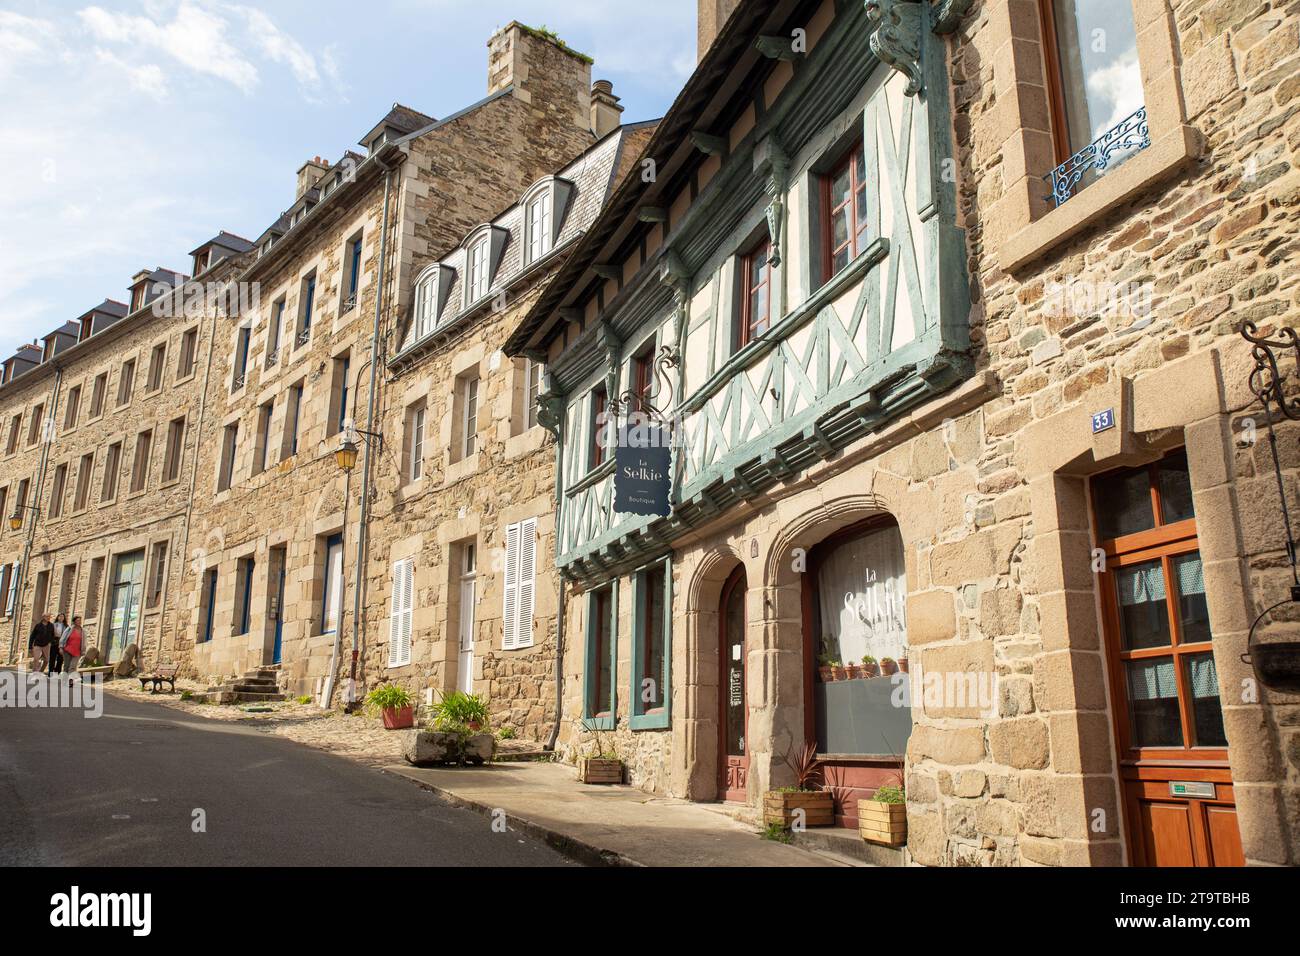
1092,451,1244,866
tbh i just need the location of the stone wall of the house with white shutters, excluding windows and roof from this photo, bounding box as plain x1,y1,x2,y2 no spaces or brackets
363,280,558,741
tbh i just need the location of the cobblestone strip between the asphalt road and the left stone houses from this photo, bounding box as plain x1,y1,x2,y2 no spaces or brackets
96,680,541,767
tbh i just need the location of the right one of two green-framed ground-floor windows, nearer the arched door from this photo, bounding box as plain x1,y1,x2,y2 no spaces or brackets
631,561,672,730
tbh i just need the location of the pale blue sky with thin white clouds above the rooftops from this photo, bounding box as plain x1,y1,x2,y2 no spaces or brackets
0,0,696,355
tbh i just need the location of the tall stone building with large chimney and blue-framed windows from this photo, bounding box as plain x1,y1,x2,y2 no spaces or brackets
183,23,618,701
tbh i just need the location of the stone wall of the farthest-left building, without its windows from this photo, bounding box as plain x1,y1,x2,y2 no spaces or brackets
0,260,243,665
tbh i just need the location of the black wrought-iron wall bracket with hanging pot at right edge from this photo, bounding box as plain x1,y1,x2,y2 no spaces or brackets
1242,321,1300,693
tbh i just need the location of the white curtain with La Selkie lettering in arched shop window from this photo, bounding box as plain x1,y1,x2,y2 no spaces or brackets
816,527,907,663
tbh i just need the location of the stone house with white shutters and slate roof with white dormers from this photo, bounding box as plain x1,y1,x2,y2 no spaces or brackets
361,113,653,740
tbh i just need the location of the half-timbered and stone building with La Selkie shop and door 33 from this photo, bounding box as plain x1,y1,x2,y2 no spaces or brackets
507,0,1300,865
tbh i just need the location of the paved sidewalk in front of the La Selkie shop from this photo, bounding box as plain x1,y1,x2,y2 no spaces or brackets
384,763,850,866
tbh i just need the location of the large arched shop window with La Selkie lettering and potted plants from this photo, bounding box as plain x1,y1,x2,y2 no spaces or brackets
806,519,911,757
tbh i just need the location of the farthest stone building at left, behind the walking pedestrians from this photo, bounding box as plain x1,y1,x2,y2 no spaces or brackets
0,243,251,665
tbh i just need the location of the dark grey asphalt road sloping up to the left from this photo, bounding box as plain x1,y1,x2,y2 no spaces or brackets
0,675,572,866
